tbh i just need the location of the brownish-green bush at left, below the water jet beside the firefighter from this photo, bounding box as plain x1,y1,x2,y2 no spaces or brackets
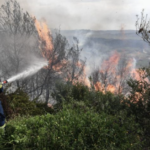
5,89,53,118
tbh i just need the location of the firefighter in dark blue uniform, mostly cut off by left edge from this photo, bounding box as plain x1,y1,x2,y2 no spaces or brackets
0,83,5,128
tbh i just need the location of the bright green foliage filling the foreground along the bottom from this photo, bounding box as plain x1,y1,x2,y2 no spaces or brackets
0,105,141,150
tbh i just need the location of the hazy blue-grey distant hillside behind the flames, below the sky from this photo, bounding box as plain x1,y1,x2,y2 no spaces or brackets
61,30,150,67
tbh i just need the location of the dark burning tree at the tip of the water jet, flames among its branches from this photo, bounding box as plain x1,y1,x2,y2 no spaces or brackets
36,29,84,103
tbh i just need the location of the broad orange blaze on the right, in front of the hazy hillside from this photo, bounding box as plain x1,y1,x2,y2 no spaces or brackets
88,52,148,94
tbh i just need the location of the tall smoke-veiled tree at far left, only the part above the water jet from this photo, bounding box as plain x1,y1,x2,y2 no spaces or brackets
0,0,39,87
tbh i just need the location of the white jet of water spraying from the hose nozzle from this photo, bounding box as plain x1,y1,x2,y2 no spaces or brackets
7,59,48,82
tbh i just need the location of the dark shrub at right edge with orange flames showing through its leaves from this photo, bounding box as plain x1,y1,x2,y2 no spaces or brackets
125,67,150,148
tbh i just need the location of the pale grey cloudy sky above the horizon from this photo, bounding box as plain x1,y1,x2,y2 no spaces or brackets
0,0,150,30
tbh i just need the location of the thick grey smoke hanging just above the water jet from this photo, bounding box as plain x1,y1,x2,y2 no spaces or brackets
0,30,42,78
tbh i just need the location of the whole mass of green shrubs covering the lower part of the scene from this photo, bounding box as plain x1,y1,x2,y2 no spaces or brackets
0,80,150,150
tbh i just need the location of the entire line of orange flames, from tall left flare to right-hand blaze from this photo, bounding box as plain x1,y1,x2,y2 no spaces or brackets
35,19,149,97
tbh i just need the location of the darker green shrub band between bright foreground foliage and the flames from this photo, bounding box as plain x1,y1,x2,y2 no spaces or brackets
54,82,150,149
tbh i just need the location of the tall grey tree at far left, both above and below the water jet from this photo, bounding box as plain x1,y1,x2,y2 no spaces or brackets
0,0,50,99
